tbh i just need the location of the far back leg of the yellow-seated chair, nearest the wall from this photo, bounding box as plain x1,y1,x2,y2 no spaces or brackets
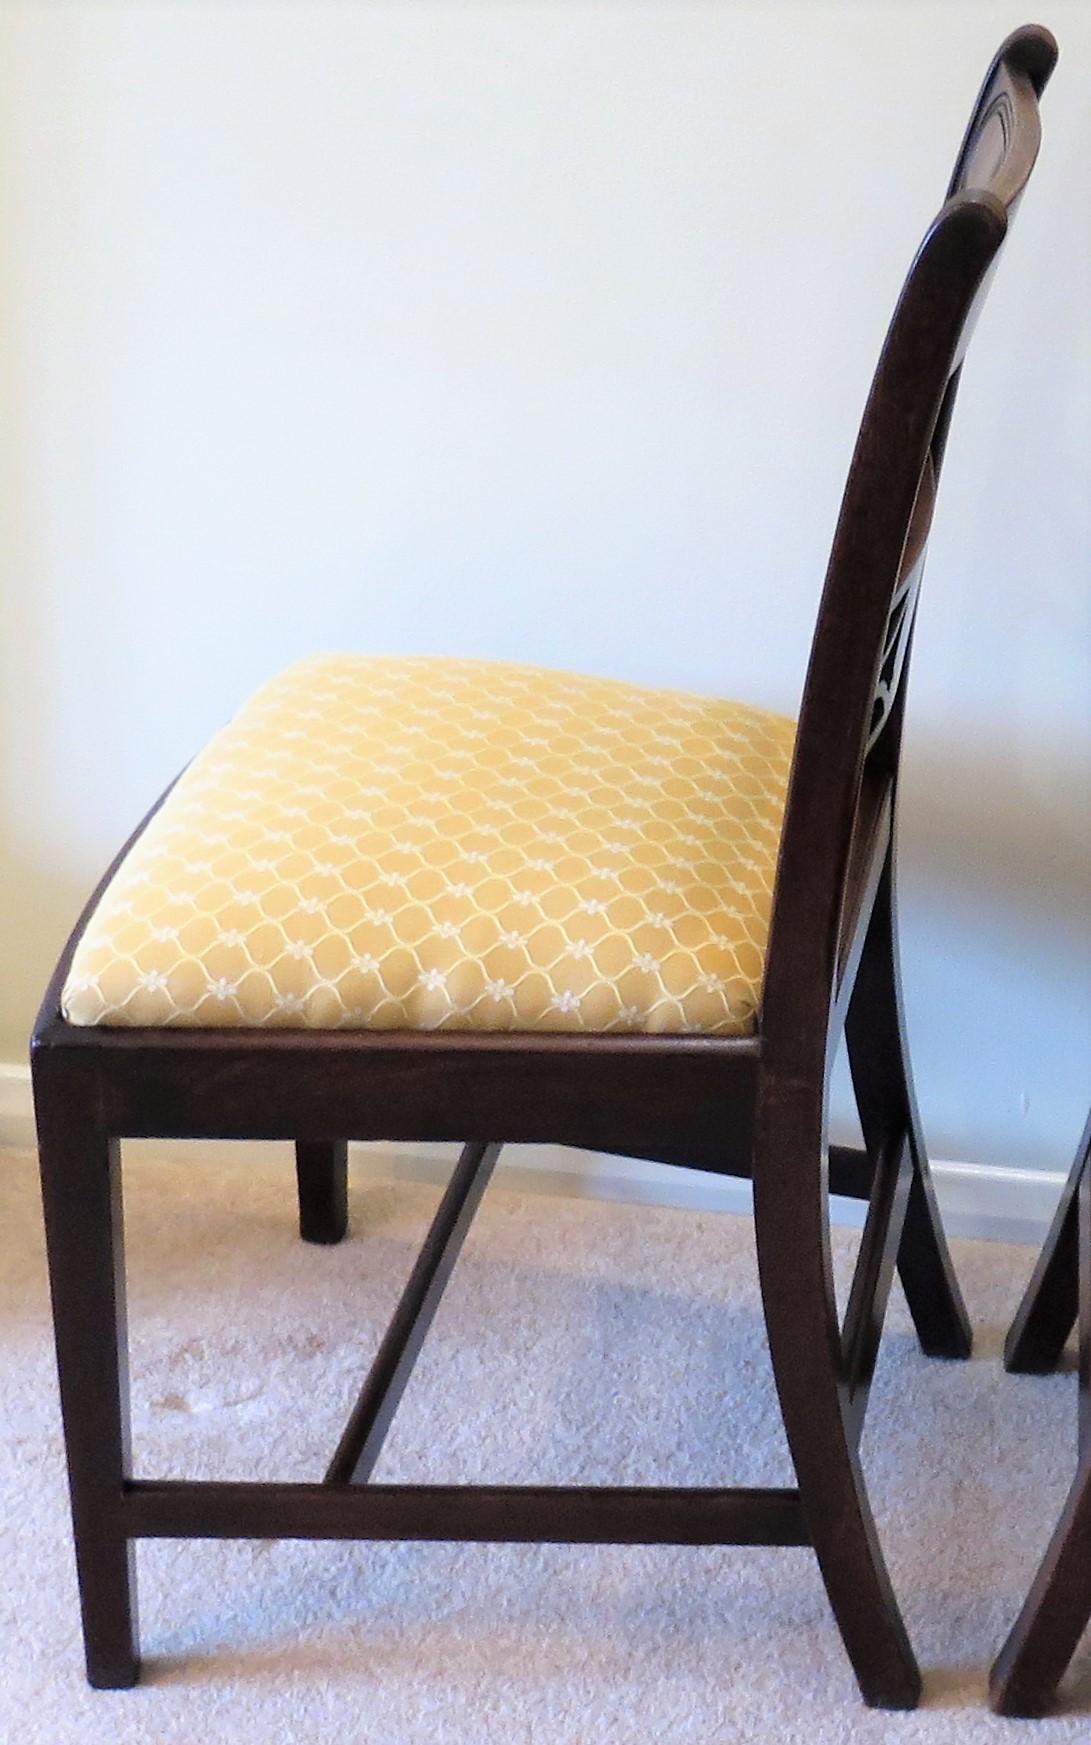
845,852,972,1358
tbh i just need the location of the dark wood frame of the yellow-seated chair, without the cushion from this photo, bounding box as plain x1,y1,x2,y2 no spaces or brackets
31,28,1056,1708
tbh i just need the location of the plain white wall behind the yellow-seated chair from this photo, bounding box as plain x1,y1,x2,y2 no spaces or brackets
0,0,1091,1167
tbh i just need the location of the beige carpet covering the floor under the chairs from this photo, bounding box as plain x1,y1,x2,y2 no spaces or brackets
0,1153,1091,1745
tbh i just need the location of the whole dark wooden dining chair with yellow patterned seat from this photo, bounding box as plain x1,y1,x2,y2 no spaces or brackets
33,28,1056,1708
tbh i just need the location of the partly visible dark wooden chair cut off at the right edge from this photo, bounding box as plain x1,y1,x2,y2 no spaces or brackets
990,1115,1091,1715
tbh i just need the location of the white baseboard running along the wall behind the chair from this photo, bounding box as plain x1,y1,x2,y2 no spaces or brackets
0,1061,1065,1242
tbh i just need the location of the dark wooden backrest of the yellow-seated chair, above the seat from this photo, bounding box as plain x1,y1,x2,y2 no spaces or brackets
761,26,1056,1071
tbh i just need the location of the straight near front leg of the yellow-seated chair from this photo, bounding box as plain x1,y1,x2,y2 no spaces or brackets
35,1063,140,1689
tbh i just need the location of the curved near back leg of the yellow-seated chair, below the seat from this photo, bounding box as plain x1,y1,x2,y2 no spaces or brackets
754,1095,920,1708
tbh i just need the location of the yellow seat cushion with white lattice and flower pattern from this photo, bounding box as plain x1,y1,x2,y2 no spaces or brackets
63,656,794,1035
